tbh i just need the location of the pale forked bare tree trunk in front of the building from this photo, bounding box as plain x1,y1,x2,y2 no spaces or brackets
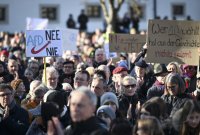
100,0,125,32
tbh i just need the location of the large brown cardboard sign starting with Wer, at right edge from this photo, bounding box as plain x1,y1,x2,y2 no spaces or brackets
145,20,200,65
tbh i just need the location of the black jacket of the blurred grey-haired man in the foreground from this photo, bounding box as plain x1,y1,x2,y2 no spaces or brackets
64,116,108,135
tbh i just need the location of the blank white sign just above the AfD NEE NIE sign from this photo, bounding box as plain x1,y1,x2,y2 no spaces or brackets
26,17,49,30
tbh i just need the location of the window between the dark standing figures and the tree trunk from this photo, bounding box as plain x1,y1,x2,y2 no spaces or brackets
86,5,101,18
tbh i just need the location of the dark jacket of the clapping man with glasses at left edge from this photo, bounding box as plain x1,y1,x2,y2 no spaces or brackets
0,103,29,135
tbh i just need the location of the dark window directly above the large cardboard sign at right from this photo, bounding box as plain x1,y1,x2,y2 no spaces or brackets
172,4,185,16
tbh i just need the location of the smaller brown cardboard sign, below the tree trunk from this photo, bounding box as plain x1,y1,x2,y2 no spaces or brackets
109,34,146,53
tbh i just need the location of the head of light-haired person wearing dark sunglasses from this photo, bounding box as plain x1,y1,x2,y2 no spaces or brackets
121,76,137,96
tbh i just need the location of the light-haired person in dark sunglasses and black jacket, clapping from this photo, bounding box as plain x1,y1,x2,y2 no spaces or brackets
118,76,138,122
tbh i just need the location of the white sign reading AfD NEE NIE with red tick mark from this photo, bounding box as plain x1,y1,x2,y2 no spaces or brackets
26,30,62,57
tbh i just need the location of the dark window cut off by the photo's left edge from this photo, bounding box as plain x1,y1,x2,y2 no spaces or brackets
0,5,8,23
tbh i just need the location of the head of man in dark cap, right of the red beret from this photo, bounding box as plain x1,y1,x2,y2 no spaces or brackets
135,60,148,77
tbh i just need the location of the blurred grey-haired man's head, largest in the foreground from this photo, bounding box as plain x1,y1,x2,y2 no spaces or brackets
69,86,97,122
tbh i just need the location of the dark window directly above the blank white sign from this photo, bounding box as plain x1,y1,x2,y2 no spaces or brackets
40,5,59,22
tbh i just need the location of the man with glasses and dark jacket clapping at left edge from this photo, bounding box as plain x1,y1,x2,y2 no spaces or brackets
0,83,29,135
